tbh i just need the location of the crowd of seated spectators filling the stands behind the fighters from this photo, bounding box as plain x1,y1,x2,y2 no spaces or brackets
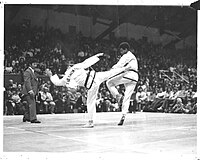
4,23,197,115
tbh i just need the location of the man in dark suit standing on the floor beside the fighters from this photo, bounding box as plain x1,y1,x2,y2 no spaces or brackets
22,58,41,123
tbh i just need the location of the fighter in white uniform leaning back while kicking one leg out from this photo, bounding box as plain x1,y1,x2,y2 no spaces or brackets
46,53,130,128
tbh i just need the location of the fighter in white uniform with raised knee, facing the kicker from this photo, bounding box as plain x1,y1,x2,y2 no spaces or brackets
106,42,138,125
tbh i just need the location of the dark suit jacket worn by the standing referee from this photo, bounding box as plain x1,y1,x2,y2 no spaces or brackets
22,68,38,95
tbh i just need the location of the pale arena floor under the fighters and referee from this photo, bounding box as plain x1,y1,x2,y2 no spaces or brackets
3,112,197,159
